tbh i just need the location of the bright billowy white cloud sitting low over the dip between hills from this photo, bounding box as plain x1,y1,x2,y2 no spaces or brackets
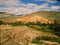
10,7,32,15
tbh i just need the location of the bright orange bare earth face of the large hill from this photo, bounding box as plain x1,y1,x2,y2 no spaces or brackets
15,15,53,23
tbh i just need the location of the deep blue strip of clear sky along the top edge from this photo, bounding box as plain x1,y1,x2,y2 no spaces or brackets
20,0,60,5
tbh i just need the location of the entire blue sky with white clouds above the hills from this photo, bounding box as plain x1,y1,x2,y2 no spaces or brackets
0,0,60,15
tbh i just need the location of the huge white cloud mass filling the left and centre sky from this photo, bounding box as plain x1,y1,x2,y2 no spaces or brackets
0,0,48,14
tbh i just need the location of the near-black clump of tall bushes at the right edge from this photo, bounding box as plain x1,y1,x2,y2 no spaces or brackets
49,20,60,36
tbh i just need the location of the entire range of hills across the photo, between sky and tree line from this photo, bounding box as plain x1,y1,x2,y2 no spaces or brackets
0,11,60,23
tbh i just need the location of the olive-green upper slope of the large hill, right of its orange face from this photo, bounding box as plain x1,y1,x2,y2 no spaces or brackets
31,11,60,21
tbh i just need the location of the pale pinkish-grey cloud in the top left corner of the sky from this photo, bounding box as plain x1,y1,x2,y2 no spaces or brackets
0,0,21,7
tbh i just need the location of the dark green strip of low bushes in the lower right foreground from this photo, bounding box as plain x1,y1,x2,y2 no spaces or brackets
32,36,60,44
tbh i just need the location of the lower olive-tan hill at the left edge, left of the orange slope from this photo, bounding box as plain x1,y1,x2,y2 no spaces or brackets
0,12,20,22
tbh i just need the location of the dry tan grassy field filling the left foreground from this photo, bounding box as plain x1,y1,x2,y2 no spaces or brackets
0,25,56,45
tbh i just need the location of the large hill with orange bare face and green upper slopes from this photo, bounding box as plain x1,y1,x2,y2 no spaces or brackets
15,11,60,23
